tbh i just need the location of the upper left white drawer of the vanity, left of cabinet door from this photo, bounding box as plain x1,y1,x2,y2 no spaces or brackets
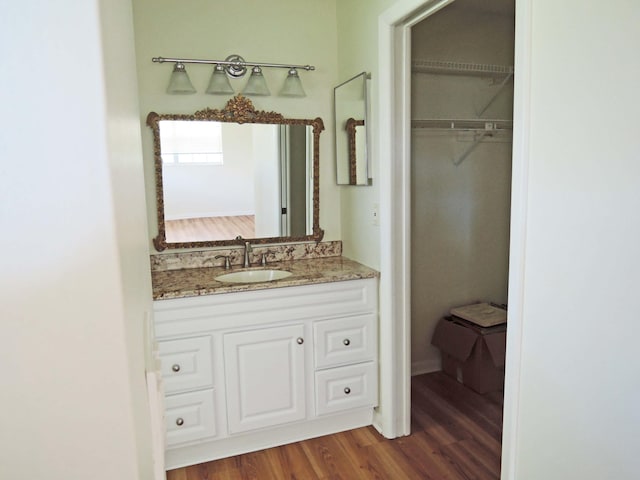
158,335,213,393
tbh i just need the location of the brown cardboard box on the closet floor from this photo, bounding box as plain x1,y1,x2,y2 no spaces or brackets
431,317,507,393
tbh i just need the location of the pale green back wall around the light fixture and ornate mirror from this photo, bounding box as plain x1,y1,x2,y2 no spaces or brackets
133,0,341,253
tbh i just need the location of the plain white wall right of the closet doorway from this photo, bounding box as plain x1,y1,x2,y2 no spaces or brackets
505,0,640,480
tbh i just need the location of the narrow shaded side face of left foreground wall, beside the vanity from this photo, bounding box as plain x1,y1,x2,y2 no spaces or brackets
100,0,158,474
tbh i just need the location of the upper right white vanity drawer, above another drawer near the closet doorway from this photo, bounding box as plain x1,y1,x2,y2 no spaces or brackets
313,314,376,368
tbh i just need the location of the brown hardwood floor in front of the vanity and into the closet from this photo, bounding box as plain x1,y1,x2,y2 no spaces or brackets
167,372,502,480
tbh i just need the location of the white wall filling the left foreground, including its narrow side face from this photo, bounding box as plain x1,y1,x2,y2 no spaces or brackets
0,0,152,480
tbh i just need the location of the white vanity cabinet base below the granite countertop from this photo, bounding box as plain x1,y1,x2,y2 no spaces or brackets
154,278,378,469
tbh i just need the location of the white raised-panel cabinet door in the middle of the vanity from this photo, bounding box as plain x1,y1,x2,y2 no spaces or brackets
224,324,306,433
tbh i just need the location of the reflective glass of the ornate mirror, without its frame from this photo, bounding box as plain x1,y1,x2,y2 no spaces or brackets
159,120,313,243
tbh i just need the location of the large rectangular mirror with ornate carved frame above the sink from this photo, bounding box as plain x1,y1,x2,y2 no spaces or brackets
147,95,324,251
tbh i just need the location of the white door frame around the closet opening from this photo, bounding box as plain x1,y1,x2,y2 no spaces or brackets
375,0,532,480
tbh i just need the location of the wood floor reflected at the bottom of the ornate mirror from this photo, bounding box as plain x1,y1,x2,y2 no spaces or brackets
164,215,256,243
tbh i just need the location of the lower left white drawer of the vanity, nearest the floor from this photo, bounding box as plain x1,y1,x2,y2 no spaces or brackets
164,389,216,447
